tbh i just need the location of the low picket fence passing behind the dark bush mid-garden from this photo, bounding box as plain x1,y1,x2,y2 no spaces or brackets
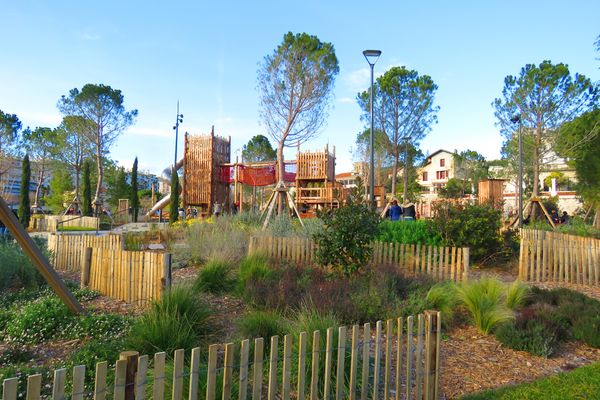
248,236,469,281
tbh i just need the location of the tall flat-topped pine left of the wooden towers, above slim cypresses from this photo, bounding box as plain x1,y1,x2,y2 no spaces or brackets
58,84,138,215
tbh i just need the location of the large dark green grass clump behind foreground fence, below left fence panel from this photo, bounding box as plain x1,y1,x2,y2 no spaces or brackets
127,286,215,354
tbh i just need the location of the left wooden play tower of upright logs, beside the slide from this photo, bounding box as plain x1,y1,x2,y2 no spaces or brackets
183,128,231,214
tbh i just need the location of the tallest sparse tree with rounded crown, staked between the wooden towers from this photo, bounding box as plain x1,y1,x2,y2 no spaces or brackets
258,32,339,212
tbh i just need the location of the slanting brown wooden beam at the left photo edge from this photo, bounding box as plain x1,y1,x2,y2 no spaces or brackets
0,196,85,314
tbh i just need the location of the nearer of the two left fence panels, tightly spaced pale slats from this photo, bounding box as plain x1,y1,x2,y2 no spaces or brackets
88,248,171,305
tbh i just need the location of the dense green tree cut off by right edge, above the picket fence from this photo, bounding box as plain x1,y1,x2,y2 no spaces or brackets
557,108,600,229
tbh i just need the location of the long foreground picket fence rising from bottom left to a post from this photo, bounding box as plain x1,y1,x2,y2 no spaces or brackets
3,311,441,400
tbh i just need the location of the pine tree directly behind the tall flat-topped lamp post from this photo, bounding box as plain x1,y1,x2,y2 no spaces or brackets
357,67,439,200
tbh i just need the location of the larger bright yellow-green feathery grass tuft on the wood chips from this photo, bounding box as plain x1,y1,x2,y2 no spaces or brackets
456,278,514,335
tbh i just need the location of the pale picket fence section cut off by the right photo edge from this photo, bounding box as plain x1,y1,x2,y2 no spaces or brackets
519,229,600,286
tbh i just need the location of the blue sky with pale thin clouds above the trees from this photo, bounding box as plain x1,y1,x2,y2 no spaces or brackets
0,0,600,173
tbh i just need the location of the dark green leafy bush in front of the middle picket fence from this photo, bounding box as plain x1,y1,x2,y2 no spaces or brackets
315,203,380,275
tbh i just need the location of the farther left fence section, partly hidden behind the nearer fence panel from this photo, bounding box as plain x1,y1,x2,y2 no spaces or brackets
48,233,123,272
